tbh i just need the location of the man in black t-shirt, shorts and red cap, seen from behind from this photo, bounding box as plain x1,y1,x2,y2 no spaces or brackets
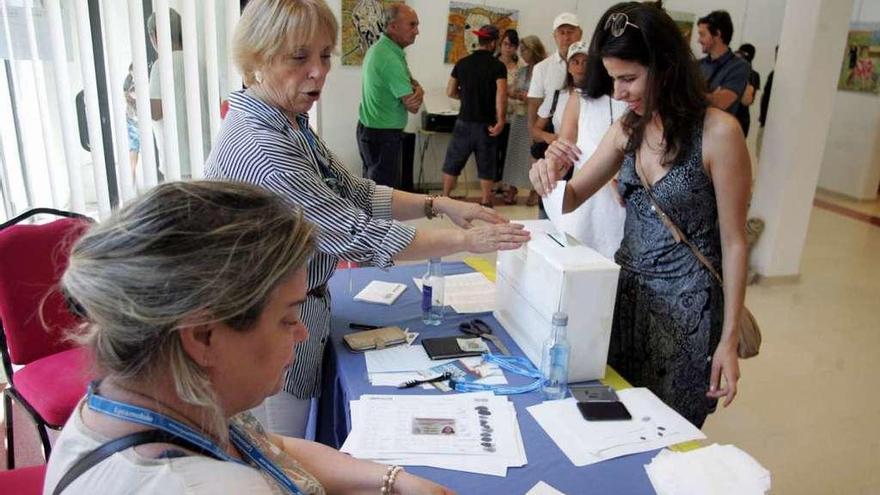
443,24,507,208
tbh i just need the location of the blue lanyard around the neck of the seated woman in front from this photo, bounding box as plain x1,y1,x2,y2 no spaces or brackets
88,382,302,495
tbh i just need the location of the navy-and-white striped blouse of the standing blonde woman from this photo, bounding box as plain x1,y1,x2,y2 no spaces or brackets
205,91,415,399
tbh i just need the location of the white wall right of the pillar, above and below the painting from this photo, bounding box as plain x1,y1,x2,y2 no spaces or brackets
819,0,880,199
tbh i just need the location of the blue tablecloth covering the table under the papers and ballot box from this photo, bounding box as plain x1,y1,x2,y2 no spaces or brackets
317,263,656,494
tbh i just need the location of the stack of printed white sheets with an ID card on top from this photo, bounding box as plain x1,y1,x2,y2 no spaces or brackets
340,392,527,476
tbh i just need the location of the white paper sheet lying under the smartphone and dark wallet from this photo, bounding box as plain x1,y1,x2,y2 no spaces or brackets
527,388,706,467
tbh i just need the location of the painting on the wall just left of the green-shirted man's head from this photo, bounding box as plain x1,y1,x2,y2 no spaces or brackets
340,0,403,65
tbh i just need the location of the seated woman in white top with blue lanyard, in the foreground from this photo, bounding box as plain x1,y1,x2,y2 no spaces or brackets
44,182,451,495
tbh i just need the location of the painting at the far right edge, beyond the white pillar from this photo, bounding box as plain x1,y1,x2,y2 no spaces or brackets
837,23,880,95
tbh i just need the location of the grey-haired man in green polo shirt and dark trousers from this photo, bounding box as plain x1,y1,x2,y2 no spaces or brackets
357,4,425,188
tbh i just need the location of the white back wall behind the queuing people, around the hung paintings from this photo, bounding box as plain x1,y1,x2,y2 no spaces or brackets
319,0,785,182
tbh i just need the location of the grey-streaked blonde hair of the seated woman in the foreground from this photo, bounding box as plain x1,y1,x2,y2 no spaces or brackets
61,181,315,441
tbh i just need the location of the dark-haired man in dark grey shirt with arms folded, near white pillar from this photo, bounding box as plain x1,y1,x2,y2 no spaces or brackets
697,10,751,120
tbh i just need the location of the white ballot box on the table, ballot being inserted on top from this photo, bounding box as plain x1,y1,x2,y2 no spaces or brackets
494,220,620,382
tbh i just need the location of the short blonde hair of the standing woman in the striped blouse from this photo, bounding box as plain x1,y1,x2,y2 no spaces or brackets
232,0,339,85
